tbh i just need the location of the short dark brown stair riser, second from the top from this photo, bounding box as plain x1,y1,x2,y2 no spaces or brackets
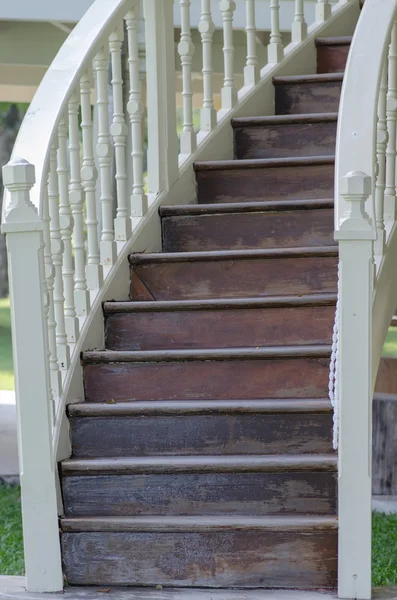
275,81,342,115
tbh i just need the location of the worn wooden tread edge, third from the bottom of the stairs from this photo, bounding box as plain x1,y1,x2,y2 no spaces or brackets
68,398,332,417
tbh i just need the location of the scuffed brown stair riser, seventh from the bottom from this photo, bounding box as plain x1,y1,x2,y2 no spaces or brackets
162,208,335,252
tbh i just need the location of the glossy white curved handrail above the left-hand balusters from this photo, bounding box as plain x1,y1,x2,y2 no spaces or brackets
2,0,129,222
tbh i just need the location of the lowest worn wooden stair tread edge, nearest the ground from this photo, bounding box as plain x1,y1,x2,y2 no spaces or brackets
61,515,338,532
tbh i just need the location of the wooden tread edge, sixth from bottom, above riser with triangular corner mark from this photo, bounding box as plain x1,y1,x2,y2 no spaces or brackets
128,245,338,266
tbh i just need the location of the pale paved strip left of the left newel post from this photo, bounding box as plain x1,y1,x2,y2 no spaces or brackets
0,391,19,478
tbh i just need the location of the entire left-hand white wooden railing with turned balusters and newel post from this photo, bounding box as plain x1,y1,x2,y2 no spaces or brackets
2,0,358,592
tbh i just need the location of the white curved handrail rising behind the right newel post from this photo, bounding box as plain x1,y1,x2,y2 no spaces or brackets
335,0,397,231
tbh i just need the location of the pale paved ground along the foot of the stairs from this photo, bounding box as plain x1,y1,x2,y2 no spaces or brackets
0,576,397,600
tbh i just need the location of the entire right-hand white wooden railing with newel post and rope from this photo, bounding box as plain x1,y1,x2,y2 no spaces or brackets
335,0,397,599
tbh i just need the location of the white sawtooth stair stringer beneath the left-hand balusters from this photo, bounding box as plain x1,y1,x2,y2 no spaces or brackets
53,0,360,464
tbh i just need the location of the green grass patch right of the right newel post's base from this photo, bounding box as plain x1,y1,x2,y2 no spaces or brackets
372,512,397,586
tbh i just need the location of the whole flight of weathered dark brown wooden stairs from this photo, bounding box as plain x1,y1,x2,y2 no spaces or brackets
61,38,350,589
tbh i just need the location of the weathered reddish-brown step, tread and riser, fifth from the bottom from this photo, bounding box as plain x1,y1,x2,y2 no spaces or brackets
104,294,336,350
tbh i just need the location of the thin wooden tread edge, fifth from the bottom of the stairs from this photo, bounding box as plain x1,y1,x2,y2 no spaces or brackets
103,293,337,315
